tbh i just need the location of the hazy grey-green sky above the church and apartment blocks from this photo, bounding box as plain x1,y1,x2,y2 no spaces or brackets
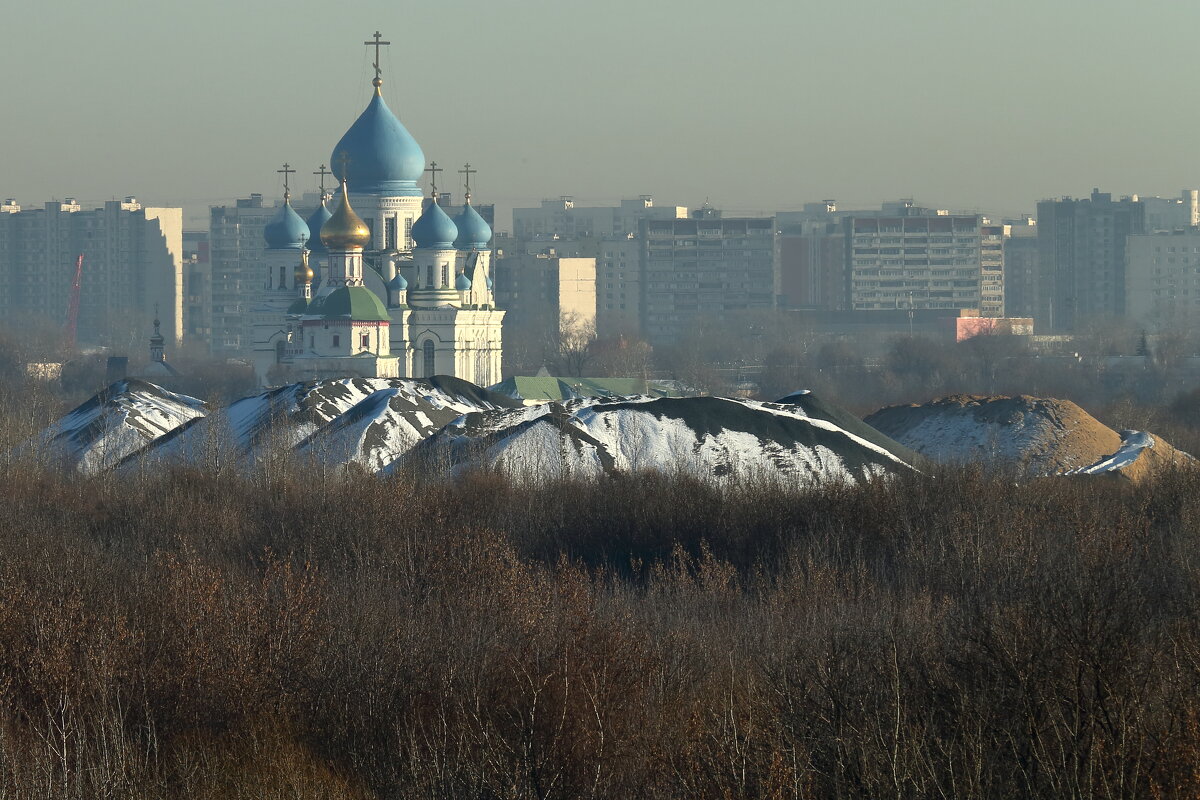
0,0,1200,227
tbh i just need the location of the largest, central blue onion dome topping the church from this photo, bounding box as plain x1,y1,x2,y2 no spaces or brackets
329,78,425,197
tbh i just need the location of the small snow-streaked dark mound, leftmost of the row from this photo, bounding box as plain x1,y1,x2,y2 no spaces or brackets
24,378,205,474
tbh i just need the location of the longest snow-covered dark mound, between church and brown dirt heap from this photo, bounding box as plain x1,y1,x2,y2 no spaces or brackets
404,397,912,486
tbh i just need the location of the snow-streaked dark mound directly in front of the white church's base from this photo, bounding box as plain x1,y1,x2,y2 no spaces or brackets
118,377,517,471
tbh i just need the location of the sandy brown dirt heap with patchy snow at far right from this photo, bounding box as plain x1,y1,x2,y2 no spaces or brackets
864,395,1190,480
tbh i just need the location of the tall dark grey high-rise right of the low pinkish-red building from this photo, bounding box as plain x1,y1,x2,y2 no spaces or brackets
1034,190,1146,332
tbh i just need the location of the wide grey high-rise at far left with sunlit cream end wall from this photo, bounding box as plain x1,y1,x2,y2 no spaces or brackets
0,197,184,348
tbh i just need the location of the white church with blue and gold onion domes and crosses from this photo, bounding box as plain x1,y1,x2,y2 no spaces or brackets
251,32,504,386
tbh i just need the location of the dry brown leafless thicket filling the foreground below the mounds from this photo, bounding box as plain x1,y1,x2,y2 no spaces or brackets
0,453,1200,800
